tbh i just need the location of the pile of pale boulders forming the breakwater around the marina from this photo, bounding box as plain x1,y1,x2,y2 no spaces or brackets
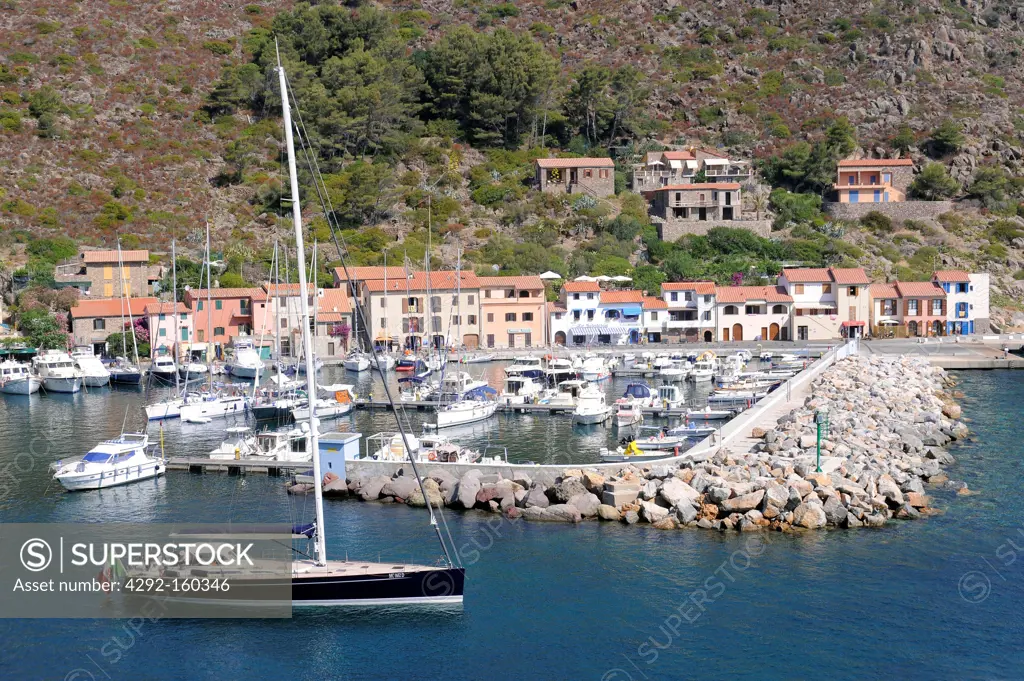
290,356,968,531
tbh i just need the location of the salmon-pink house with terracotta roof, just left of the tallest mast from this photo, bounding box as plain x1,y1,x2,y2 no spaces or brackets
185,289,273,346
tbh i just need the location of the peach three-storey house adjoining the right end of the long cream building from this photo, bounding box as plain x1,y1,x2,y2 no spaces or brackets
479,276,546,348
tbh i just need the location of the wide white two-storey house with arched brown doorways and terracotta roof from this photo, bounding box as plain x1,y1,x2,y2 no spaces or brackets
716,286,793,341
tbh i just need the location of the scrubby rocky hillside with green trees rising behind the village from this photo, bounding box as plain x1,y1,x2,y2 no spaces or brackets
0,0,1024,318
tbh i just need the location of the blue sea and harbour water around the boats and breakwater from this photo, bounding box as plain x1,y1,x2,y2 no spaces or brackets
0,368,1024,681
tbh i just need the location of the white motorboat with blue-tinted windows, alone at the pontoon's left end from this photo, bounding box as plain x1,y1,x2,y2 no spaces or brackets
53,433,167,492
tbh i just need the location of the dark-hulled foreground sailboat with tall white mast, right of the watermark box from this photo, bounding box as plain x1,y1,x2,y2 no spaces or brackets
274,54,466,606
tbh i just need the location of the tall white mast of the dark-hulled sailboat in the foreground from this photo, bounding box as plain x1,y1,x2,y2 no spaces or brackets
278,46,323,565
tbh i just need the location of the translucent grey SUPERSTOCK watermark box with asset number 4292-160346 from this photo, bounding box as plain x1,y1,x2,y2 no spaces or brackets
0,523,293,620
